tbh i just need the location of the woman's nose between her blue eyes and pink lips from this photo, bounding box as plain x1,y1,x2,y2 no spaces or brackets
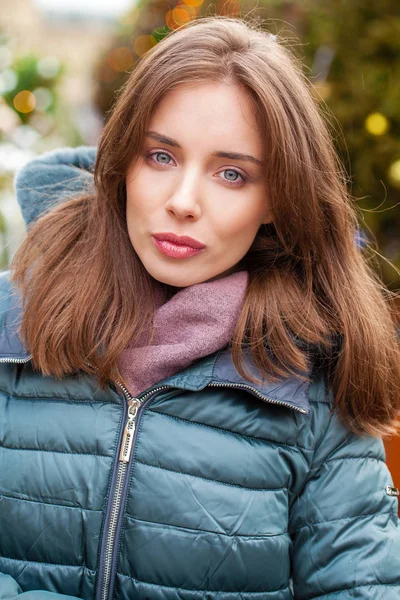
165,168,201,220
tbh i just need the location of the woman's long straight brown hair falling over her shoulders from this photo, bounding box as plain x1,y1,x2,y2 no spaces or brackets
12,17,400,436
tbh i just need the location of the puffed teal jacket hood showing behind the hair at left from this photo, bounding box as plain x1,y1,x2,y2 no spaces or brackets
14,146,97,225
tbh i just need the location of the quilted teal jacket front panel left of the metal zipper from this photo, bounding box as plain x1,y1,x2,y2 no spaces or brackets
0,378,121,595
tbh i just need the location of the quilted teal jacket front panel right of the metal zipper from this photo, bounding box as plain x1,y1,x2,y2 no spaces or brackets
117,390,312,597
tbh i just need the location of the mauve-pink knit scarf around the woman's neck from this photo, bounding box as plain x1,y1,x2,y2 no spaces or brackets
118,271,248,396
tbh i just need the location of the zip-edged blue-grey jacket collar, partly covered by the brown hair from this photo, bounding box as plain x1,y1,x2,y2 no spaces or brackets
0,284,310,414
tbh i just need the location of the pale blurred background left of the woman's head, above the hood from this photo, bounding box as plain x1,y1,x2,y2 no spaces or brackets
0,0,109,268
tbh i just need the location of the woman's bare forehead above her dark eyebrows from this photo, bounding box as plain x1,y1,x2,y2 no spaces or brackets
148,82,263,155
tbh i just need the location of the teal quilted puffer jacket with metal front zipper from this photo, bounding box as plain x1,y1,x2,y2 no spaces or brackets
0,146,400,600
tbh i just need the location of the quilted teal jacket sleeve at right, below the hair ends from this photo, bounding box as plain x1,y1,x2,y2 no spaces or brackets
289,402,400,600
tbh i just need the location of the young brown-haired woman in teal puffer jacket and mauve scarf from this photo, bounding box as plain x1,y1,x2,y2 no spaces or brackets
0,17,400,600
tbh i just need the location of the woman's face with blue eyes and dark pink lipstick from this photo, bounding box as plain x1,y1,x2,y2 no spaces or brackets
126,82,272,287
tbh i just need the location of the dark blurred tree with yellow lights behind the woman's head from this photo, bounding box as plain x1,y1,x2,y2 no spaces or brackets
95,0,400,289
